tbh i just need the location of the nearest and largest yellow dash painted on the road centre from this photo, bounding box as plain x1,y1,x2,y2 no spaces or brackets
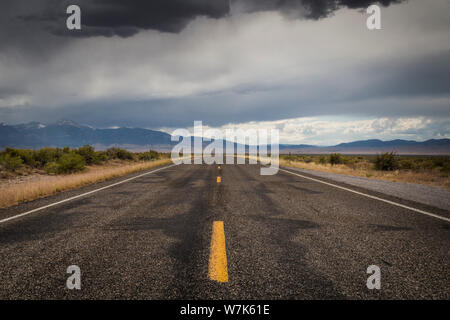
208,221,228,282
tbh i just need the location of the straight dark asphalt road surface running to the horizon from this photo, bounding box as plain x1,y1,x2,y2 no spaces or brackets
0,165,450,299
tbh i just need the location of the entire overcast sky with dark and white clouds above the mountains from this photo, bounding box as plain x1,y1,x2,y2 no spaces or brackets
0,0,450,145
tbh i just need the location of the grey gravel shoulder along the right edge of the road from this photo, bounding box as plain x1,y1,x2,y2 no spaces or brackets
286,167,450,210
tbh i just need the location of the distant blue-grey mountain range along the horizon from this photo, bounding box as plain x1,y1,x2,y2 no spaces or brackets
0,120,450,155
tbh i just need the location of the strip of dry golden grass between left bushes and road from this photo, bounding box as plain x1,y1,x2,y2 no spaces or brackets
0,159,172,208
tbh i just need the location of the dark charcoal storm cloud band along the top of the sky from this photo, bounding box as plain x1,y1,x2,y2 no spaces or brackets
0,0,402,37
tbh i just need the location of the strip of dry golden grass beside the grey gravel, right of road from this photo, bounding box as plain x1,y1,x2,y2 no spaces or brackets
280,159,450,189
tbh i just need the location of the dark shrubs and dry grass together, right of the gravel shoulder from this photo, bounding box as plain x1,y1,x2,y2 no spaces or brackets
280,152,450,189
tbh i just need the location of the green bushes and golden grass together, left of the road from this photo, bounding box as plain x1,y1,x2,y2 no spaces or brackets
0,145,171,208
